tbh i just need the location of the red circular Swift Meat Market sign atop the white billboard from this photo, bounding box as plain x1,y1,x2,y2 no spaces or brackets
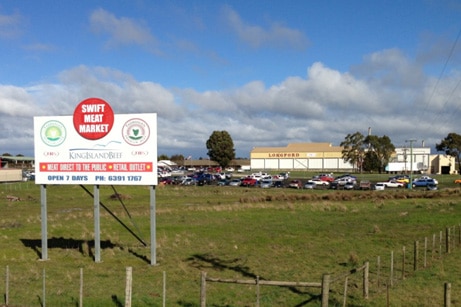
74,98,114,140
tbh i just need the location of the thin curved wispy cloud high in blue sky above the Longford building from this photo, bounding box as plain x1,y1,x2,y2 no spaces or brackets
223,6,309,50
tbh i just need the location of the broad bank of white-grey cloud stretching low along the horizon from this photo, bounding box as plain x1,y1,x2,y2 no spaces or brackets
0,50,461,157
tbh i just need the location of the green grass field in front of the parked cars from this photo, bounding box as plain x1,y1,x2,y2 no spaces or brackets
0,174,461,306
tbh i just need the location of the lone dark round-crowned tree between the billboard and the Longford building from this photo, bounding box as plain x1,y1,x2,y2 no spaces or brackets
206,131,235,168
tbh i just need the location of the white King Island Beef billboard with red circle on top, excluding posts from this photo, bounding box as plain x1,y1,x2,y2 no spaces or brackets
34,98,158,185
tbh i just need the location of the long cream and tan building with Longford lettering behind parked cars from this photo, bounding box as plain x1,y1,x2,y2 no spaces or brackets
250,143,354,172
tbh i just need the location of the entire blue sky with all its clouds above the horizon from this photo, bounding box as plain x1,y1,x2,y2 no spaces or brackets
0,0,461,159
